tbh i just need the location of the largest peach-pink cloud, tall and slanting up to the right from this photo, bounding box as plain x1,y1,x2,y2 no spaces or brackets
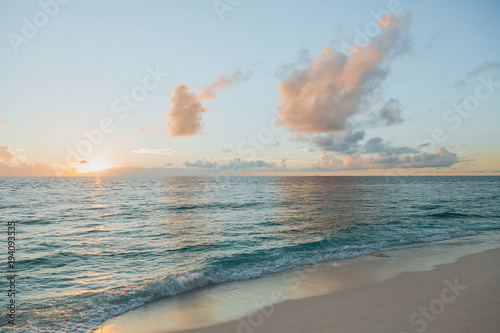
277,15,411,134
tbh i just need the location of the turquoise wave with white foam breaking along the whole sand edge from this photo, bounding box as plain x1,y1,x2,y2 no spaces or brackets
13,230,488,333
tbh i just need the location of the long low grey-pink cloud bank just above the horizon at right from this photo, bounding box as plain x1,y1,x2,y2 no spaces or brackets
312,148,460,170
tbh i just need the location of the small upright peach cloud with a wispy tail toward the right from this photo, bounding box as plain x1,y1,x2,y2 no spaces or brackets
167,71,250,137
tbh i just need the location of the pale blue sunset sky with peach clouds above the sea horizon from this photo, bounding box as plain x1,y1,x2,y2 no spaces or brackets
0,0,500,176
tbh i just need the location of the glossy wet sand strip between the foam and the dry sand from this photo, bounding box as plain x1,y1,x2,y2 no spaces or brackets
95,240,500,333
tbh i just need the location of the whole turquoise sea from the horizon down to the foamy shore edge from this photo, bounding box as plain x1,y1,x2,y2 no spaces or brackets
0,177,500,332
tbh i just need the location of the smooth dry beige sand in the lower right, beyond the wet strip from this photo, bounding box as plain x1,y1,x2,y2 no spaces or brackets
174,248,500,333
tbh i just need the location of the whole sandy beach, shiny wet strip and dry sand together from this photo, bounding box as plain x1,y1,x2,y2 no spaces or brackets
96,243,500,333
